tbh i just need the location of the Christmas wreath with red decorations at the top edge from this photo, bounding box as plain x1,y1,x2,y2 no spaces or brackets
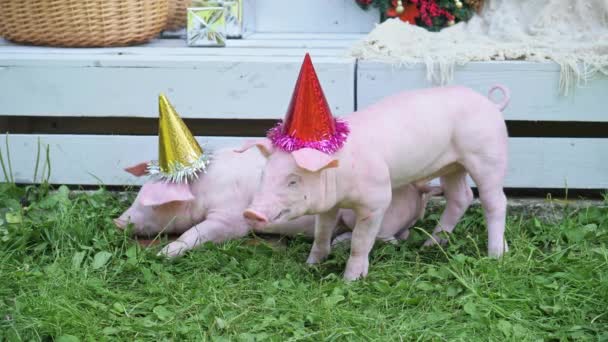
355,0,483,31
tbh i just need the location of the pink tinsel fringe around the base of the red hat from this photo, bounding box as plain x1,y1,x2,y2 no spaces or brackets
268,119,350,154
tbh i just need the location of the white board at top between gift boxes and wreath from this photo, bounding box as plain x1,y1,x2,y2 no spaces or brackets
255,0,380,33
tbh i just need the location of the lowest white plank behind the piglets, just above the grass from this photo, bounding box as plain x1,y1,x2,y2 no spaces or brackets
9,135,608,189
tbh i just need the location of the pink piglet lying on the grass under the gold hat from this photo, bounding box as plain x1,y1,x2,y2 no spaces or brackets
115,149,440,257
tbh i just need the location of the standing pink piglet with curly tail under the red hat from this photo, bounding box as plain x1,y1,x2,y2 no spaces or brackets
242,86,509,280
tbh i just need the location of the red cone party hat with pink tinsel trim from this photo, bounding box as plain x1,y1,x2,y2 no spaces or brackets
268,54,349,154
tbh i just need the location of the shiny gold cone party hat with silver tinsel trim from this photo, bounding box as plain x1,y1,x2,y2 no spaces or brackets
148,94,208,183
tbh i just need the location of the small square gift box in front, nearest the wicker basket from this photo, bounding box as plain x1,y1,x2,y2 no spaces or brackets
186,6,227,47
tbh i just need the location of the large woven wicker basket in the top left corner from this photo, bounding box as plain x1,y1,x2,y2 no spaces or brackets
0,0,168,47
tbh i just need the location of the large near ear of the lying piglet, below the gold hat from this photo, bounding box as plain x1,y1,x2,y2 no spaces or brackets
138,182,194,206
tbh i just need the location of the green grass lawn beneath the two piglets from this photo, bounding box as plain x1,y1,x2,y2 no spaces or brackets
0,184,608,341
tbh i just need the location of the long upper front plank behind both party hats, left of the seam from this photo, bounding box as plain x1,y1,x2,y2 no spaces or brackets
0,54,354,119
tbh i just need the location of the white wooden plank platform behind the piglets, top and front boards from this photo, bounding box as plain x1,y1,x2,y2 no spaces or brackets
0,33,608,189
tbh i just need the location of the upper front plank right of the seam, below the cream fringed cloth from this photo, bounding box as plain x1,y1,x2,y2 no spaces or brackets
357,61,608,122
